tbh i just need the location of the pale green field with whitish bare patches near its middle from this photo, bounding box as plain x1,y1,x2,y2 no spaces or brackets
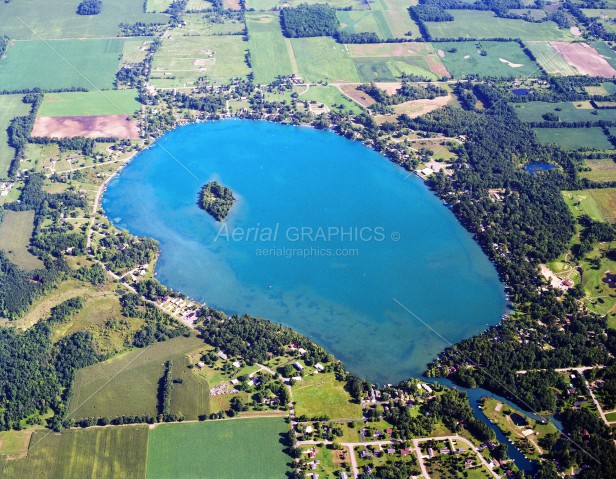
150,35,250,88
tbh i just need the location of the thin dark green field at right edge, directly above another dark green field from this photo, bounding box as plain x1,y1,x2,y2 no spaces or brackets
510,101,616,122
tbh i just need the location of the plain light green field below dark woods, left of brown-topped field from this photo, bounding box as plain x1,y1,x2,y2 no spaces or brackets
291,37,360,82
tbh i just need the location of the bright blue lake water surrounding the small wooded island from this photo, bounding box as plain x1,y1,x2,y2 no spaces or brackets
103,120,505,383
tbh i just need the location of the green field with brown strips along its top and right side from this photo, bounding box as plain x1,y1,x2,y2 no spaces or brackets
347,42,449,82
